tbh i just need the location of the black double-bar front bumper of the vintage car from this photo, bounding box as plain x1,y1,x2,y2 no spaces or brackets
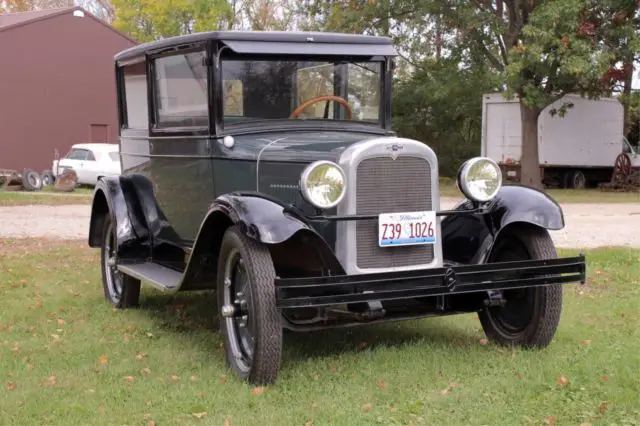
275,254,586,309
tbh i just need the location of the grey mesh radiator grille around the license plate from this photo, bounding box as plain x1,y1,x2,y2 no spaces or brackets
356,157,434,269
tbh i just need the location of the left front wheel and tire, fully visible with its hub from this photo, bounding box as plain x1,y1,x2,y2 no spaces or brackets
217,226,282,385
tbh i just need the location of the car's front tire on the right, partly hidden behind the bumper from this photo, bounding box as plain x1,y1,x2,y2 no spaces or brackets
478,226,562,348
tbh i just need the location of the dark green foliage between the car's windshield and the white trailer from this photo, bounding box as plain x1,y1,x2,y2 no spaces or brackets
393,59,500,176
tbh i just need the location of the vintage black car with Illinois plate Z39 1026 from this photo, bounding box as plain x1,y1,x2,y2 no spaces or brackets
89,32,585,384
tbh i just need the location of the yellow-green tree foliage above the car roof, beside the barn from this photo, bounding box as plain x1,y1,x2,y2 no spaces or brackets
112,0,231,42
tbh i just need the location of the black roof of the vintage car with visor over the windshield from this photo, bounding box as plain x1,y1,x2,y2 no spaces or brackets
115,31,397,62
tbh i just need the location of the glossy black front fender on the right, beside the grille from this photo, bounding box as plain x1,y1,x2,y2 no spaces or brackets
441,185,564,264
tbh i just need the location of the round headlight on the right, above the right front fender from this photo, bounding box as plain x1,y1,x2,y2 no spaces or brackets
458,157,502,202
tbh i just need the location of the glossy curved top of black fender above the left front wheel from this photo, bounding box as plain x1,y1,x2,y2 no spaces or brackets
205,193,315,244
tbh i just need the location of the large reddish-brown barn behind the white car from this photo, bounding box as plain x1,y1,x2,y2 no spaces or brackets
0,7,136,172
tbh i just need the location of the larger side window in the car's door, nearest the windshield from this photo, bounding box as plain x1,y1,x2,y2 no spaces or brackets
154,52,209,128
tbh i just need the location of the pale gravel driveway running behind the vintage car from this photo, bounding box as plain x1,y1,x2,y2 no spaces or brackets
0,199,640,248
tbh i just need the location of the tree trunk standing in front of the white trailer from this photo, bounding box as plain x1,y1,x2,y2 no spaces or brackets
520,102,542,189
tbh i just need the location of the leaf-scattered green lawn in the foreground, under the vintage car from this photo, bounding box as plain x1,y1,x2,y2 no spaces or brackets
0,240,640,425
